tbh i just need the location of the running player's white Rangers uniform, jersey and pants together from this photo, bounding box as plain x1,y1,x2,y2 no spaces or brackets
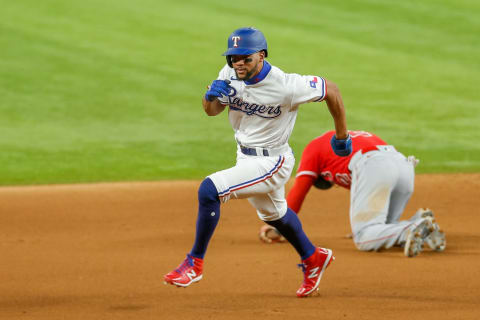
209,61,327,221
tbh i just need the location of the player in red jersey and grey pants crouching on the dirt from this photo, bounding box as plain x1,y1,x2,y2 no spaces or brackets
260,131,446,257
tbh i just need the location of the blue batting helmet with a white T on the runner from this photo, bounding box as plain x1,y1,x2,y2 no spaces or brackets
223,27,268,67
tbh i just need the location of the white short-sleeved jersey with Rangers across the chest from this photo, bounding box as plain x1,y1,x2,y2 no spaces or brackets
218,61,327,148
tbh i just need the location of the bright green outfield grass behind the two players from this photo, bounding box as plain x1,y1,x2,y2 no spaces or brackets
0,0,480,185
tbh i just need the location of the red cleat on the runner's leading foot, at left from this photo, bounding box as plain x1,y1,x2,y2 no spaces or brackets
163,254,203,287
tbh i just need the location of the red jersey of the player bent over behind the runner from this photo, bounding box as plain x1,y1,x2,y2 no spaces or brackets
296,131,387,189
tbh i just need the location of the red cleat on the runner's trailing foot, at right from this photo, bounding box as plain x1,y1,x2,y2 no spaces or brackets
297,248,335,298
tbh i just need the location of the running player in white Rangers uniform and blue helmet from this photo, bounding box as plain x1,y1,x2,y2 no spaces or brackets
164,28,352,297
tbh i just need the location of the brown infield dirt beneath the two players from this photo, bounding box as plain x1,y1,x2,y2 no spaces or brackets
0,174,480,320
